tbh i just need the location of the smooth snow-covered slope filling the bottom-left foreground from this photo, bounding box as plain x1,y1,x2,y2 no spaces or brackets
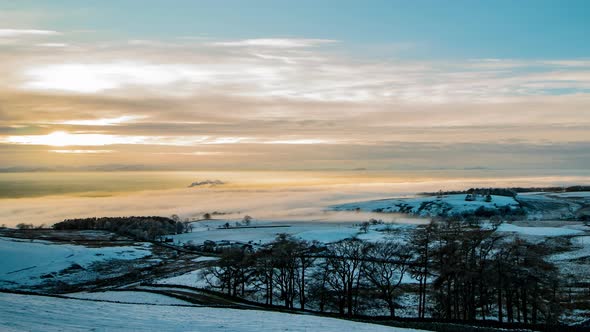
0,293,428,332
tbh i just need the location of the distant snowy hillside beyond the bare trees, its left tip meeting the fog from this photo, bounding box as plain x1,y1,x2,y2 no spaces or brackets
332,194,519,216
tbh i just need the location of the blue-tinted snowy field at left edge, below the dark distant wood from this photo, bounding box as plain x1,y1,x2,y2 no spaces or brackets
0,237,151,287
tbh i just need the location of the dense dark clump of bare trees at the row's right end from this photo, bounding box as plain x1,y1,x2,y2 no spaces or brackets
411,221,560,324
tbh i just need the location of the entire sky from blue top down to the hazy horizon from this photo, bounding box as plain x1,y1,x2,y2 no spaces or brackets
0,0,590,175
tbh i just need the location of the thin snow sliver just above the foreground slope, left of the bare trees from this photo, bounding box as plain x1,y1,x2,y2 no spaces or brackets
65,291,190,305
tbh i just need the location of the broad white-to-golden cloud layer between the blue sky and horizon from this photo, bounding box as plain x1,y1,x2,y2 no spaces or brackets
0,34,590,169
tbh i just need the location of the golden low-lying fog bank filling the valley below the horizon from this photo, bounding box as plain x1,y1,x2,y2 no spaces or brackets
0,172,588,226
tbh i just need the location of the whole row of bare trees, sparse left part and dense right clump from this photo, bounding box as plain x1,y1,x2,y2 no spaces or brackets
204,221,560,324
